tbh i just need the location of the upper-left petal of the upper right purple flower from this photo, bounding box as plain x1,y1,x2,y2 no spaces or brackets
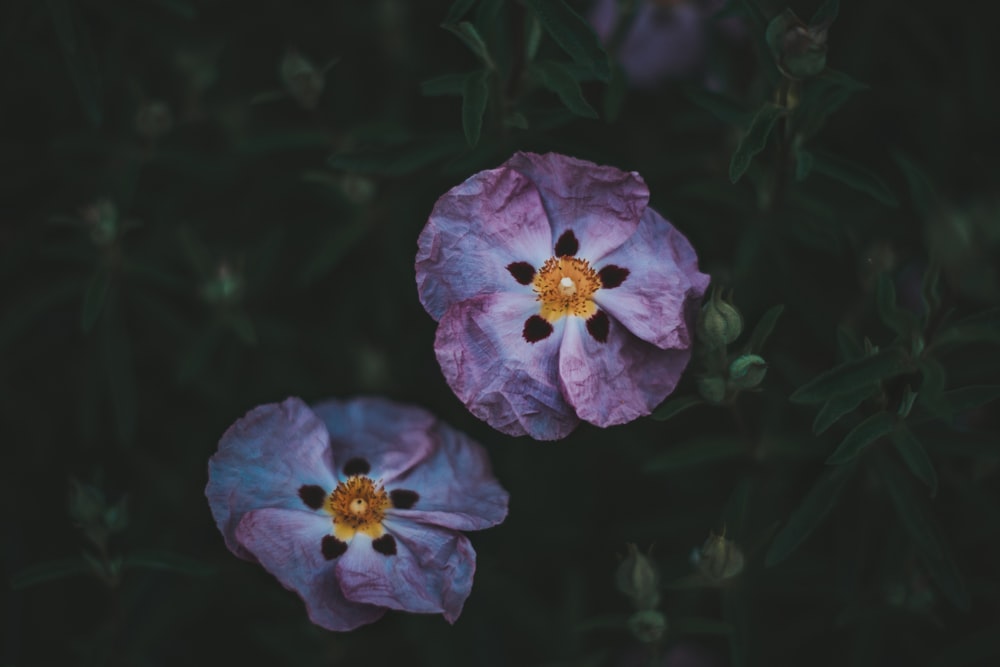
416,166,552,320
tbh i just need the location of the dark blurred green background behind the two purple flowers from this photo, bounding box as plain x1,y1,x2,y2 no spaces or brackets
0,0,1000,666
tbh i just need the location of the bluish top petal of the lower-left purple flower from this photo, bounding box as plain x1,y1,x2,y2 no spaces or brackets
313,397,437,484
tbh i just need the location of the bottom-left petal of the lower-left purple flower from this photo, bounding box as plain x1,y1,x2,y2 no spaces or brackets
236,508,386,630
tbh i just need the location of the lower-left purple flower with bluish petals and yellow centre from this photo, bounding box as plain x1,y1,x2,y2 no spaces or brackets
205,398,507,630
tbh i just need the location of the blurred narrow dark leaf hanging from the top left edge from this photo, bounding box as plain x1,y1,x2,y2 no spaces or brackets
45,0,103,127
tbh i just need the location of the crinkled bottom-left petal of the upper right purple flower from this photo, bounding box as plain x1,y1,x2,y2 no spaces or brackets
434,293,579,440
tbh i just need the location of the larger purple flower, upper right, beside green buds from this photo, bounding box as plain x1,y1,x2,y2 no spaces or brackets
416,153,709,440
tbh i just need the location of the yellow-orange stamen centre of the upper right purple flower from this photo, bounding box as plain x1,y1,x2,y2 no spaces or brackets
532,257,601,322
